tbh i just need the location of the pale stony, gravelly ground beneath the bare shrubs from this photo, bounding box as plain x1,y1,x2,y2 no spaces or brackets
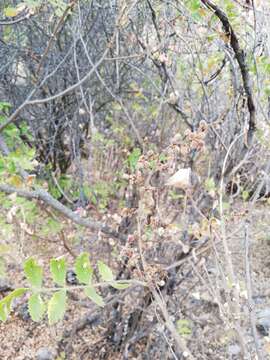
0,198,270,360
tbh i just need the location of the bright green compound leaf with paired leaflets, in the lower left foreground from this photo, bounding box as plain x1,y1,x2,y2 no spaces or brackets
0,252,136,325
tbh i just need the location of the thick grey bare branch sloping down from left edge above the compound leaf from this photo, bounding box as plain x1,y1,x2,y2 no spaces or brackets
0,184,126,243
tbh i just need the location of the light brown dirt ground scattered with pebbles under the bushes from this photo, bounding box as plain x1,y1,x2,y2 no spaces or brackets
0,202,270,360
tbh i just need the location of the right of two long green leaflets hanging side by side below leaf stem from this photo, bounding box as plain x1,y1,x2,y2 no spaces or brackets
48,290,67,325
